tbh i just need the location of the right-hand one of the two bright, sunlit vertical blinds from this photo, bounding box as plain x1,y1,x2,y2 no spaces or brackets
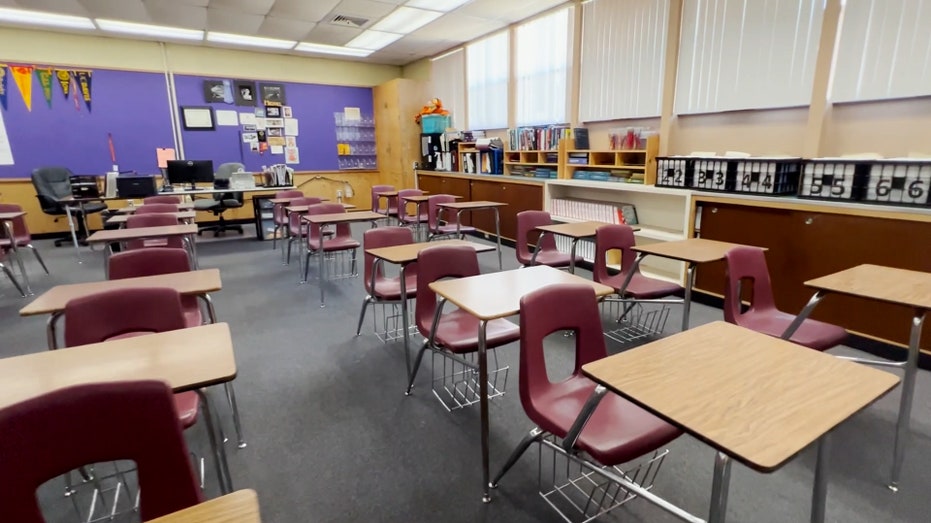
514,8,572,125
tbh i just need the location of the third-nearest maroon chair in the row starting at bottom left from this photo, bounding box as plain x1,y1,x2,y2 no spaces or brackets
107,247,204,327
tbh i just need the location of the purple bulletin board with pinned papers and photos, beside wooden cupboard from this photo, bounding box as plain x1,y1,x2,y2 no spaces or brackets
174,75,373,171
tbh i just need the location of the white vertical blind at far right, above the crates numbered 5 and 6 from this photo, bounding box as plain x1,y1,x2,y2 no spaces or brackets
831,0,931,102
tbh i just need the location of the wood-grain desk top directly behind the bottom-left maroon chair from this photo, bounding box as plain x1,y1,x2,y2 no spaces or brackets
0,323,236,408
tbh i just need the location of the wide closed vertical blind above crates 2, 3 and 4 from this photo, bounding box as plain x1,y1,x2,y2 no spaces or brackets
675,0,824,114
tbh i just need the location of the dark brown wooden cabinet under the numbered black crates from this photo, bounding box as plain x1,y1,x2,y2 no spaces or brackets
696,200,931,349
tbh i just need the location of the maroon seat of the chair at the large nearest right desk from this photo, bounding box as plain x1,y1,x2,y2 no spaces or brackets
531,376,682,465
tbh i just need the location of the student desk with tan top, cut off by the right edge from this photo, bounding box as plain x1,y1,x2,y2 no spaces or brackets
782,265,931,492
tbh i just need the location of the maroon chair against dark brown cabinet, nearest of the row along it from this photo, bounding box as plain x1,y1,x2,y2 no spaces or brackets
724,247,847,351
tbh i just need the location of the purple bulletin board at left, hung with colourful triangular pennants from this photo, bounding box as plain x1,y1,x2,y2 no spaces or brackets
0,67,175,178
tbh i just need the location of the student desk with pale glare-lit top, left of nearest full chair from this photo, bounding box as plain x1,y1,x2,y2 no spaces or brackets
430,265,614,503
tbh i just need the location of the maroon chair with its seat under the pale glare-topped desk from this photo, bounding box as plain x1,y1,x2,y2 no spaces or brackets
407,245,520,394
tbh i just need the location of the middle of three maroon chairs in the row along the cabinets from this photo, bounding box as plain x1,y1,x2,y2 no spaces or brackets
592,225,682,300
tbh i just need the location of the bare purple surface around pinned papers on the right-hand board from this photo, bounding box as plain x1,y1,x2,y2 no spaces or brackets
175,75,373,171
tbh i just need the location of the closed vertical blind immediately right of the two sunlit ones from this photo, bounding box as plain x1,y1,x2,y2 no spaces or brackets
579,0,669,122
